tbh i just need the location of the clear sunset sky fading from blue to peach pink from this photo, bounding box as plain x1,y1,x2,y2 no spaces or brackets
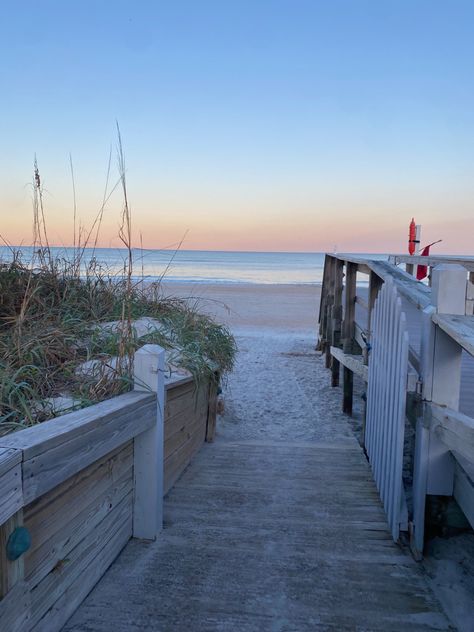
0,0,474,255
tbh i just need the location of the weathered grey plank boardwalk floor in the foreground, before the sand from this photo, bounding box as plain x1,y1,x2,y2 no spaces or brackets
61,441,448,632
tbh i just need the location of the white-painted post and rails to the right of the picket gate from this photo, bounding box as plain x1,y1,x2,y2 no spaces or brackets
412,264,474,557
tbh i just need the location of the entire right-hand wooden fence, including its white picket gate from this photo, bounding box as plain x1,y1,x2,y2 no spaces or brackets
318,255,474,557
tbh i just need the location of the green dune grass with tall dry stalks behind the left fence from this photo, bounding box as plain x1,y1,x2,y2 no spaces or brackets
0,130,236,435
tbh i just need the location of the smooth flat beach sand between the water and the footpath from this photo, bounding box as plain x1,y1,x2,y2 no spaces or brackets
163,283,321,336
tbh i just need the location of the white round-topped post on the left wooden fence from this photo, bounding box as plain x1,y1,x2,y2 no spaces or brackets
133,344,165,540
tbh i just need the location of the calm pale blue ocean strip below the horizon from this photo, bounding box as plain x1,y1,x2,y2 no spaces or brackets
0,246,384,284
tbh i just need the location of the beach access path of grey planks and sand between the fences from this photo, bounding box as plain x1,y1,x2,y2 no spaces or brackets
64,332,453,632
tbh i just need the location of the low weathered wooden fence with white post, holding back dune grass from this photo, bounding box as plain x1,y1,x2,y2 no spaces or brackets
0,345,215,632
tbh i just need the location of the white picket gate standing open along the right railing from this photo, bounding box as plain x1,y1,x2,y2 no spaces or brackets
365,278,408,540
